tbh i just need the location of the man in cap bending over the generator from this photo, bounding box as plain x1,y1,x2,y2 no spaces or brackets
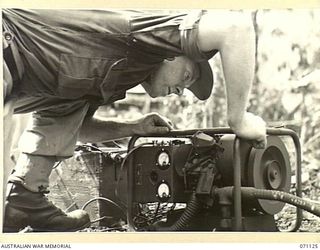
3,9,266,231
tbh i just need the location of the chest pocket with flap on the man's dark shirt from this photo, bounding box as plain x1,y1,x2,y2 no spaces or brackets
57,54,114,99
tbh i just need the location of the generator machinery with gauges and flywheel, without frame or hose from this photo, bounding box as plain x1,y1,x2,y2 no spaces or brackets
124,131,298,231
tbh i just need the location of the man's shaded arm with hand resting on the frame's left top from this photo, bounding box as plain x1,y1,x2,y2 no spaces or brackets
79,113,172,142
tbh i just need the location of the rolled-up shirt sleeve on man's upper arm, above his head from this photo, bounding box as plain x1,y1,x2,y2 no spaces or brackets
130,10,216,61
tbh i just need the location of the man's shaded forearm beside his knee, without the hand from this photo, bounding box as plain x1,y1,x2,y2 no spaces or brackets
79,117,136,142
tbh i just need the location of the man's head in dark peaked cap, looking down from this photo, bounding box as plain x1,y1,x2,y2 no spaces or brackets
142,56,213,100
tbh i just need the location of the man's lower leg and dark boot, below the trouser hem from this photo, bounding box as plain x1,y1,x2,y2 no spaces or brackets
4,153,90,232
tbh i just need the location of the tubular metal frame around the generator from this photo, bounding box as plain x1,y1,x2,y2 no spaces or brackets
127,127,302,232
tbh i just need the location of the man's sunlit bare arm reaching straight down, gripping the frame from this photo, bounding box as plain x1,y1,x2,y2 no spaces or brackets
198,11,266,146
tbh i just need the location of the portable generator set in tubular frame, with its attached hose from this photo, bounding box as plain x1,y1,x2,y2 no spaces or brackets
75,128,320,232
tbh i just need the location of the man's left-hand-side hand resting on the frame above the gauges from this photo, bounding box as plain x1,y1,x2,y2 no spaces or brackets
134,113,173,135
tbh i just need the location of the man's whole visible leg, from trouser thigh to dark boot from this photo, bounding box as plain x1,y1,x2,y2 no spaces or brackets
4,102,90,232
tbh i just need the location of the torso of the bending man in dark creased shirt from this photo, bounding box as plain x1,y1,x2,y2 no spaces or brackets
3,9,190,107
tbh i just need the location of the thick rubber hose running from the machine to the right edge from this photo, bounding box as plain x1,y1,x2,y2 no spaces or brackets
216,187,320,217
